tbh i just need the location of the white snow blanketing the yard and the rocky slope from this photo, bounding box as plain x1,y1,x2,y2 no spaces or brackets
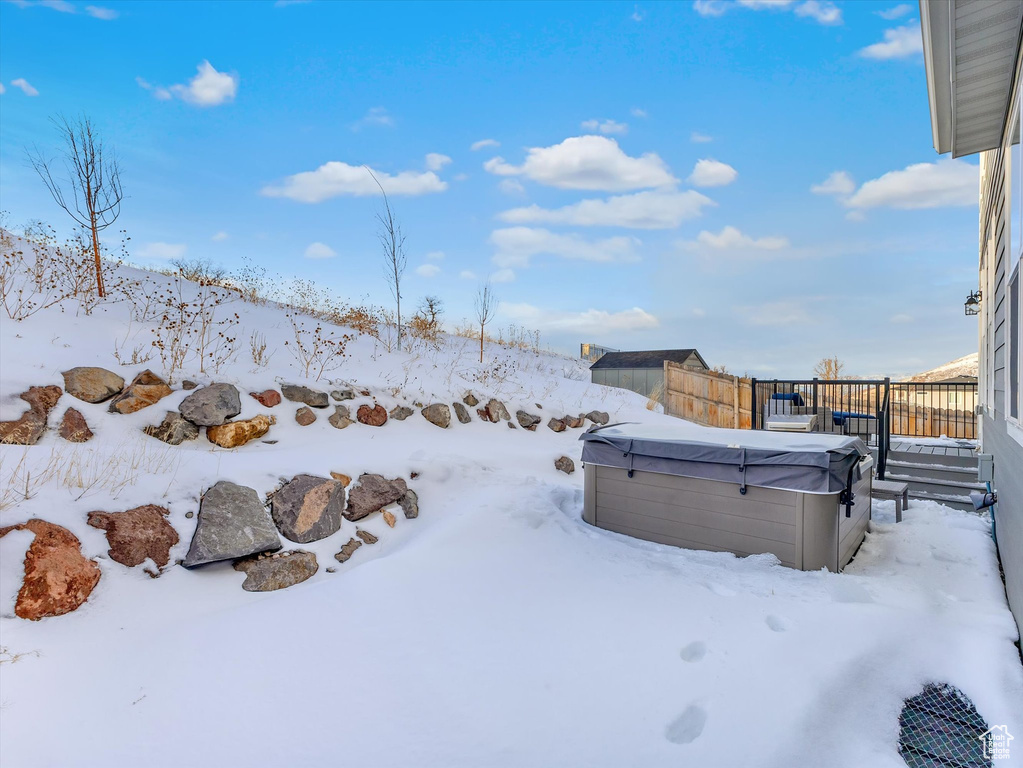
0,247,1023,768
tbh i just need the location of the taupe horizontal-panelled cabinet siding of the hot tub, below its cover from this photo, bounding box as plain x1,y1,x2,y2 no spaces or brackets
583,463,871,572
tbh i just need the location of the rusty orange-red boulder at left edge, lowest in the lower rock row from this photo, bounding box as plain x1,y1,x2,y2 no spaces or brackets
0,518,99,621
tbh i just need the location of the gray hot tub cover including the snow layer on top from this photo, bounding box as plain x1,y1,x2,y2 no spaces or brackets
579,422,869,494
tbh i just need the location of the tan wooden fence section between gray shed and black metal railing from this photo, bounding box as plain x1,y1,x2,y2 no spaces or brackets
664,361,753,430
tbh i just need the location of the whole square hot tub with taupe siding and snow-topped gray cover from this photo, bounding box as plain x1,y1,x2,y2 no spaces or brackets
580,422,873,572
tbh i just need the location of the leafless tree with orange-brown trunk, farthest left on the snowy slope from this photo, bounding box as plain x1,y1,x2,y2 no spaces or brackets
28,116,124,299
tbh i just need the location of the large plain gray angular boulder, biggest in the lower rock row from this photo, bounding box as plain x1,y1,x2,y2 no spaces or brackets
181,480,280,568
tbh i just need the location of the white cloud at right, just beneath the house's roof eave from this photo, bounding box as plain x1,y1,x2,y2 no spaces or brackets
845,159,979,210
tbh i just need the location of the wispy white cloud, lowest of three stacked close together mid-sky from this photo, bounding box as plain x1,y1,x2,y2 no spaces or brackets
490,227,641,268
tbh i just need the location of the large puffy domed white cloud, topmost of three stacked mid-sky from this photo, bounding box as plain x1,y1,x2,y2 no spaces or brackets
483,136,678,192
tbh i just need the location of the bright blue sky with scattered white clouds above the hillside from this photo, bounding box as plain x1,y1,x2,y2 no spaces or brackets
0,0,977,376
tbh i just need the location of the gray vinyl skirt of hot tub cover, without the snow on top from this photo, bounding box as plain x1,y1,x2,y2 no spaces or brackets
579,423,866,494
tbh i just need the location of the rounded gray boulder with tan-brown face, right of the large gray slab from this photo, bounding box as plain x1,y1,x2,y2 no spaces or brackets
270,475,345,544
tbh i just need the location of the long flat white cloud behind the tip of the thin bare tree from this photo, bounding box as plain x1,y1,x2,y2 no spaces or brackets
261,161,448,202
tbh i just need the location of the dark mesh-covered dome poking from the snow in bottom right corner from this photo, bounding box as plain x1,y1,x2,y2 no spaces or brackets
898,683,991,768
